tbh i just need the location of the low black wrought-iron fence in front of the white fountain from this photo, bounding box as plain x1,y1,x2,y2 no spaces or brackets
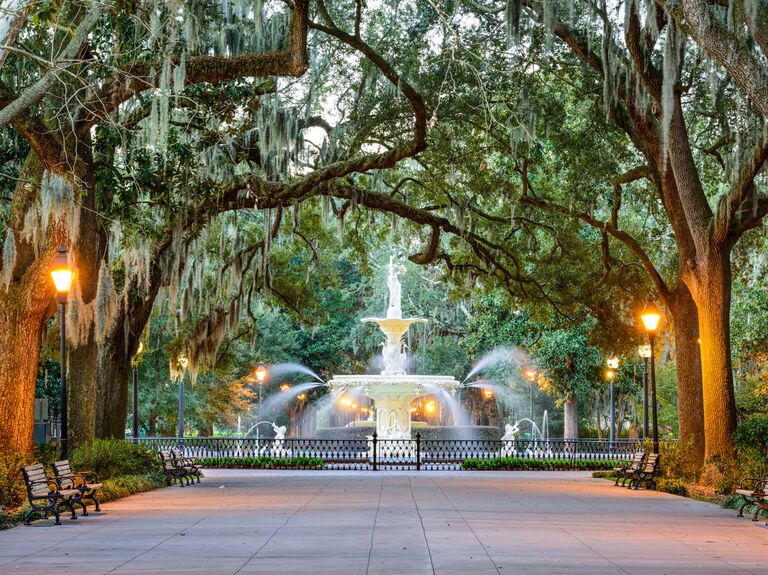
128,433,664,470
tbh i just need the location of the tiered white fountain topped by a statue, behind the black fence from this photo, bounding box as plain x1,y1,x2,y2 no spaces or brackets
328,257,459,439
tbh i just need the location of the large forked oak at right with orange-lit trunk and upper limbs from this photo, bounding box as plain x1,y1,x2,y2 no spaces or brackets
440,1,768,462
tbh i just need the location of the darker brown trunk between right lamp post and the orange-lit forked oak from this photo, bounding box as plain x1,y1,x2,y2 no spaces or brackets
670,282,705,466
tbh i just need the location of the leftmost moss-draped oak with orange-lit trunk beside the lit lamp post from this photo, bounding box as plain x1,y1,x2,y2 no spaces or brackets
0,0,307,451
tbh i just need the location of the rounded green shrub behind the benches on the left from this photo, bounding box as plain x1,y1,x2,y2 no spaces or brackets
70,439,162,480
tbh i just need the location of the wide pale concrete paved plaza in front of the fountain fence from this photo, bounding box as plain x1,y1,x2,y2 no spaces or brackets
0,470,768,575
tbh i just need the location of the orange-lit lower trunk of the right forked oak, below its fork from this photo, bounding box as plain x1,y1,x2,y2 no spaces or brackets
694,248,736,460
